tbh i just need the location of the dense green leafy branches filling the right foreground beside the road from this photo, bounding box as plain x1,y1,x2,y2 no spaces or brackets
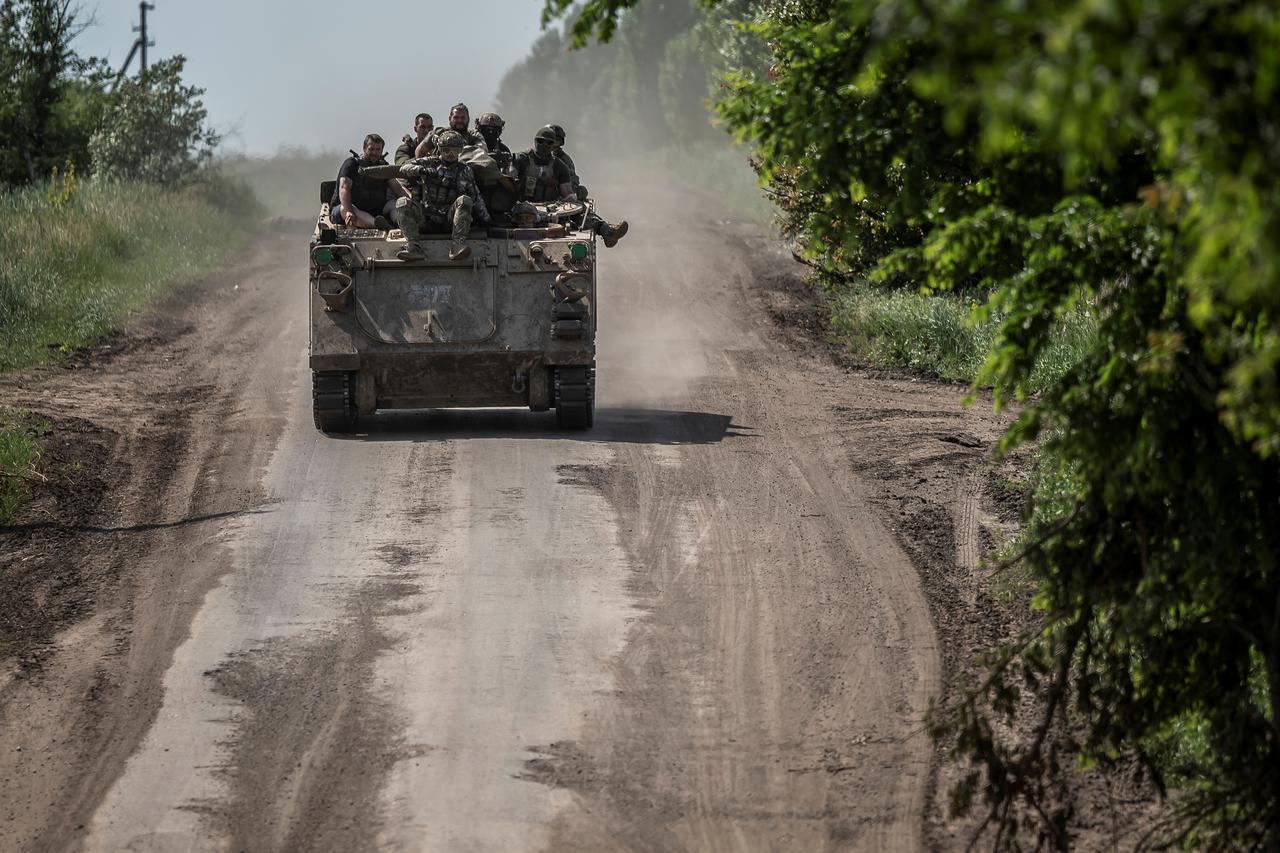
548,0,1280,849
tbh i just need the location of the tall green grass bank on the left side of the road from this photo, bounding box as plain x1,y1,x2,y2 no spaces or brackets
0,181,260,371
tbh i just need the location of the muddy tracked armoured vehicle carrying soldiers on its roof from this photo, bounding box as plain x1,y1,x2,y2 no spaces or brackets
308,181,596,433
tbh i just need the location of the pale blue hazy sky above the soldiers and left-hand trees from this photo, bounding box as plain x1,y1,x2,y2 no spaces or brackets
76,0,541,154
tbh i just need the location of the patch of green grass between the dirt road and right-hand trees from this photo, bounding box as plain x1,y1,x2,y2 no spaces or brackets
827,284,1097,393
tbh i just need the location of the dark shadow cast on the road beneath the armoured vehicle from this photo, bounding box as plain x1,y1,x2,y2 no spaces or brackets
343,409,754,444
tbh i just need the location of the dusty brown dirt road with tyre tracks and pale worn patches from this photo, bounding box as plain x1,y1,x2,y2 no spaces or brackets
0,191,997,852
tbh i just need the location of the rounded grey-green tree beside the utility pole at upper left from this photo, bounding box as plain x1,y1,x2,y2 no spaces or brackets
90,55,220,184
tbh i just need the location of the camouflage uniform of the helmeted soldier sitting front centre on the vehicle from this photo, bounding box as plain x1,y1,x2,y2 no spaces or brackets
396,156,489,251
